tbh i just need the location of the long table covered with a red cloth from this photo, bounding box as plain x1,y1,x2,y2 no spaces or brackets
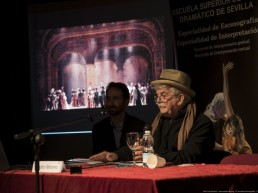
0,164,258,193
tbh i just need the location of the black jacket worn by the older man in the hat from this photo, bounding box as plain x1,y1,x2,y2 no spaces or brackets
153,107,215,165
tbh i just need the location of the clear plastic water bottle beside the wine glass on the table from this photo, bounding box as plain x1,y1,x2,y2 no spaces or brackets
142,130,154,167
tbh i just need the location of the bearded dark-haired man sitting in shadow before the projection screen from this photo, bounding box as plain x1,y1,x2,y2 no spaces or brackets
89,82,146,159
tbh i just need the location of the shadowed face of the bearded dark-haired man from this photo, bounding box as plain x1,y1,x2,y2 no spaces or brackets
105,88,128,115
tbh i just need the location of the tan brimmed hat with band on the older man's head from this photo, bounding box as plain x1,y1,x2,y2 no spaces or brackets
151,69,195,97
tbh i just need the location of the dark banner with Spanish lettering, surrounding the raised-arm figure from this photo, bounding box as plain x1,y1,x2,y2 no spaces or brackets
170,0,258,152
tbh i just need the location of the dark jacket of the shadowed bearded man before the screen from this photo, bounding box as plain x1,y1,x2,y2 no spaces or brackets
92,113,146,160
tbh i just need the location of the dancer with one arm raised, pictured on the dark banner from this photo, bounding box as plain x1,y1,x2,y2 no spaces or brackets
204,62,252,154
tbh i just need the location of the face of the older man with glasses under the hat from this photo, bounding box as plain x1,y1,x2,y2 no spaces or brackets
155,87,180,117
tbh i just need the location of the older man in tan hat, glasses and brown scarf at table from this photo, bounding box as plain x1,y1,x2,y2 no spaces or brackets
92,69,215,165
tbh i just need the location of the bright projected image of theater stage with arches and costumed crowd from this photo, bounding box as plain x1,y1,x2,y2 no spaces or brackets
34,16,165,111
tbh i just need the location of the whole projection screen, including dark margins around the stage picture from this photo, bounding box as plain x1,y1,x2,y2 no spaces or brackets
28,1,174,131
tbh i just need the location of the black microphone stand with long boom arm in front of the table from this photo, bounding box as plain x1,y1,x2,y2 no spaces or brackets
14,111,106,193
